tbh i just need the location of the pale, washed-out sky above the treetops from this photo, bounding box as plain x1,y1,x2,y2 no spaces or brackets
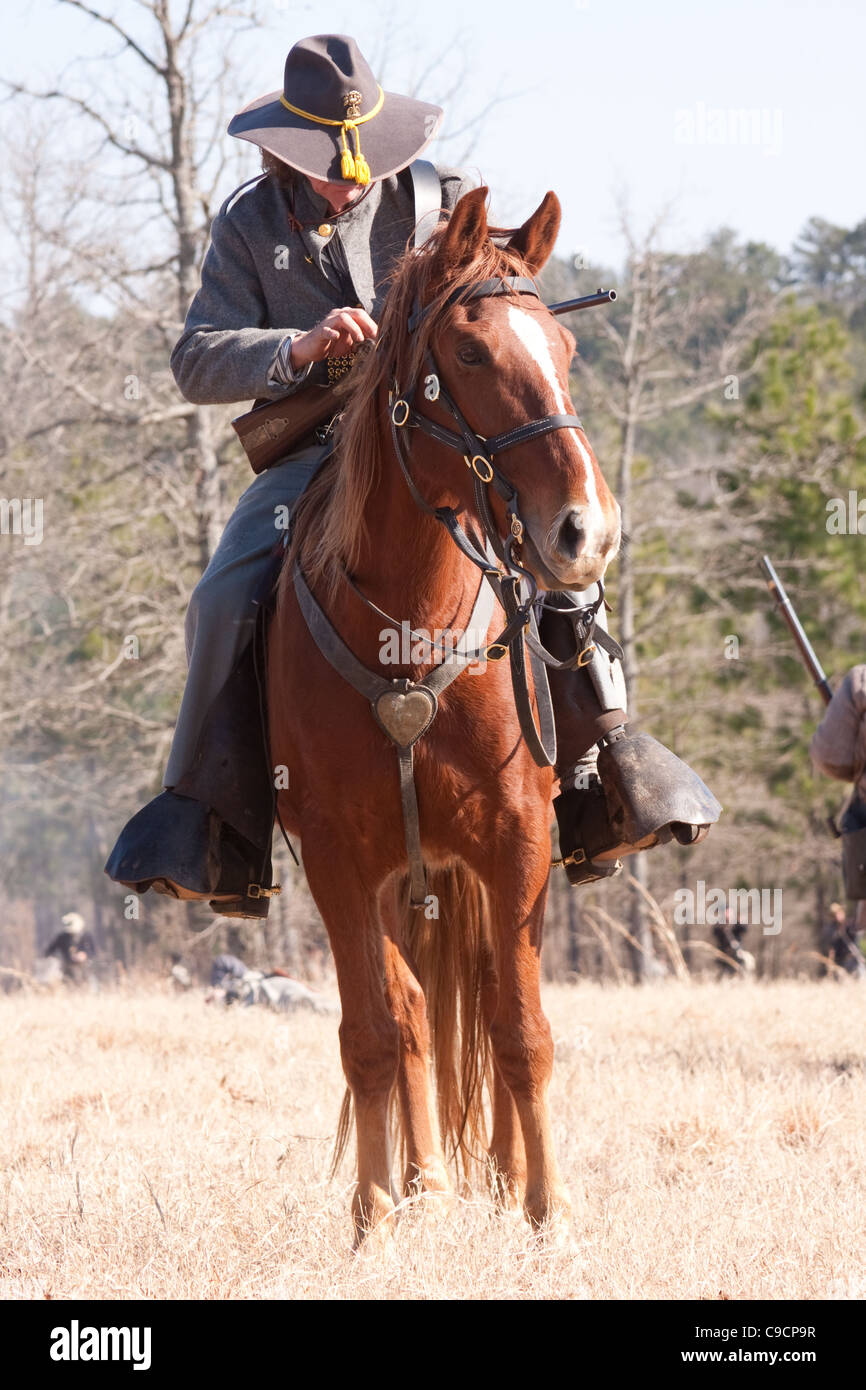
6,0,866,263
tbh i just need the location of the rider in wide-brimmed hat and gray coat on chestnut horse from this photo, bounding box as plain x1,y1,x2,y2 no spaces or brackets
106,35,717,917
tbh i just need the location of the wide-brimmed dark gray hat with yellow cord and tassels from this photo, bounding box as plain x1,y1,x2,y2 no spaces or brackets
228,33,442,183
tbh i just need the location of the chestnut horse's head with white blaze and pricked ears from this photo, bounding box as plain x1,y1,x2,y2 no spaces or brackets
413,188,620,589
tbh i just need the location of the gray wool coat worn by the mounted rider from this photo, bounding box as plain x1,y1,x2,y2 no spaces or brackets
171,167,475,406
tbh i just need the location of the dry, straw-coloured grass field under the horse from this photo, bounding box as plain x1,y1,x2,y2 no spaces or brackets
0,981,866,1300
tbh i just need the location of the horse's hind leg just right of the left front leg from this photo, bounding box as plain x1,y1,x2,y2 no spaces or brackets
385,897,452,1197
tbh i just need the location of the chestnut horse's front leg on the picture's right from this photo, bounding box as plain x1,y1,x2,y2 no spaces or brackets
488,844,571,1226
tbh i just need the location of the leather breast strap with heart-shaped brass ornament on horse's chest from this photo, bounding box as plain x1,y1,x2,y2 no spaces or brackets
292,563,495,909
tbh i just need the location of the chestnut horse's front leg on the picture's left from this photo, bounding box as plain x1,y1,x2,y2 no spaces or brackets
304,833,399,1247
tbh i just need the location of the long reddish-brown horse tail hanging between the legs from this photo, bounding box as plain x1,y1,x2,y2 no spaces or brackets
331,865,493,1177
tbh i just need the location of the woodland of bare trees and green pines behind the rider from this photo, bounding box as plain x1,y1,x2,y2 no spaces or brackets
0,0,866,977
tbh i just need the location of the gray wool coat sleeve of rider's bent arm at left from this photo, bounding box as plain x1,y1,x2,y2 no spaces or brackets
171,213,303,406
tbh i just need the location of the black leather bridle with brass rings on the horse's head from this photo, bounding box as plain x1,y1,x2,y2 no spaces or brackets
388,275,623,767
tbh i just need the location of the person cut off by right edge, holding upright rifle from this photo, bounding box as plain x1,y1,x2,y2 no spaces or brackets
809,666,866,935
